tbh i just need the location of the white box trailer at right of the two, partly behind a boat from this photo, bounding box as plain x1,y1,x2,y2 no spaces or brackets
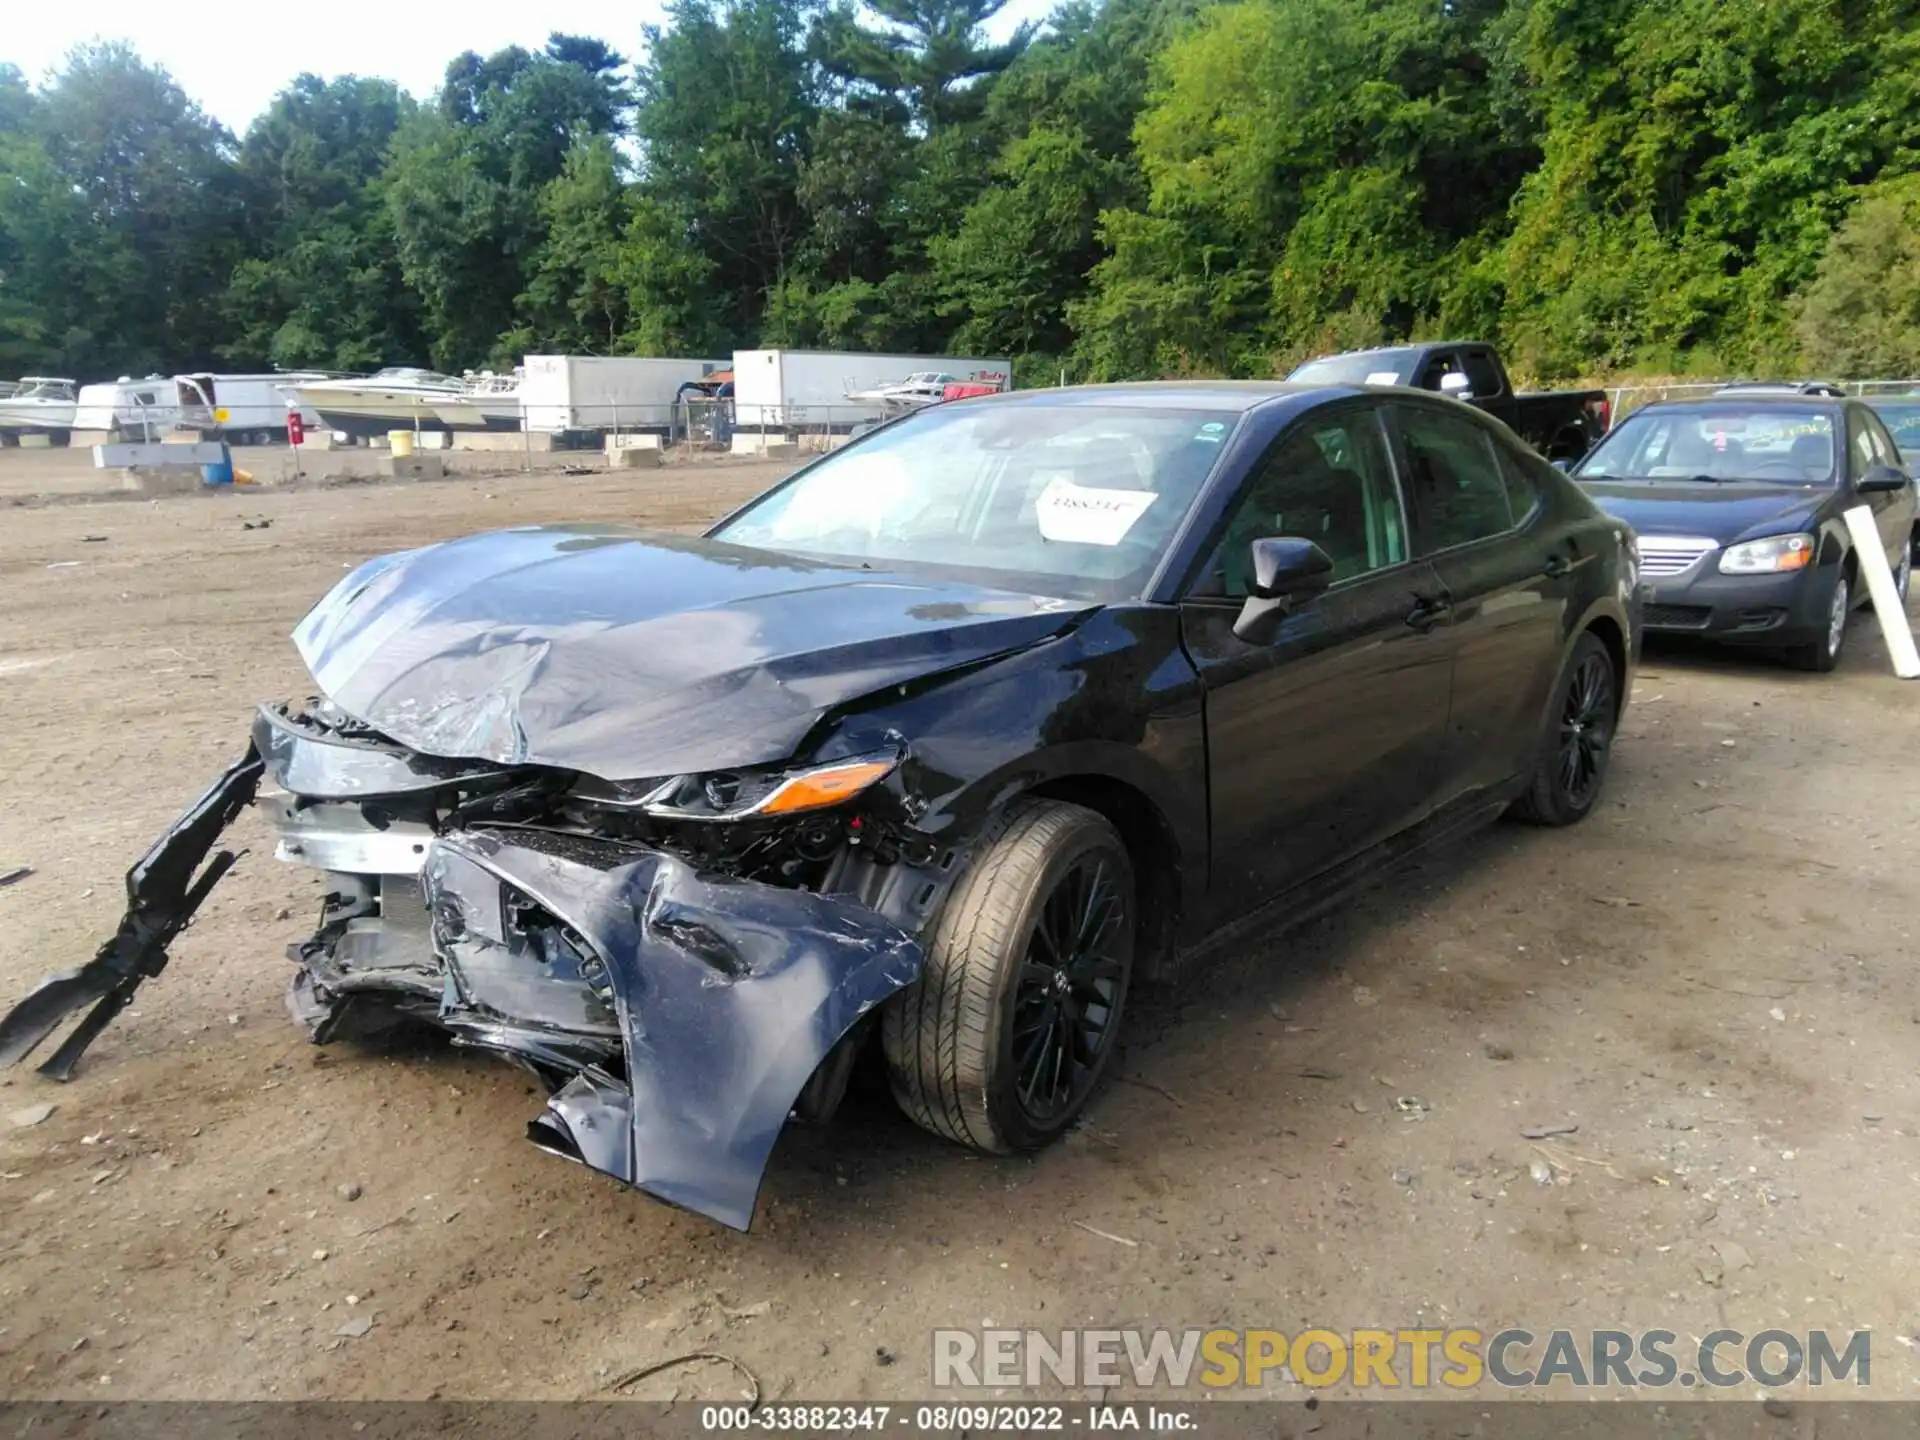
733,349,1014,432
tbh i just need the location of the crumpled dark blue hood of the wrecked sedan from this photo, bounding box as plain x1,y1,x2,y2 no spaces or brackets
294,526,1092,780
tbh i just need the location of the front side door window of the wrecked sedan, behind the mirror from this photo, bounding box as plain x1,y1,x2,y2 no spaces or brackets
1196,409,1407,599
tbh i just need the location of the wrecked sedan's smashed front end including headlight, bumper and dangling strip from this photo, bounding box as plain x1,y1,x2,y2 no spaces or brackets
0,703,925,1229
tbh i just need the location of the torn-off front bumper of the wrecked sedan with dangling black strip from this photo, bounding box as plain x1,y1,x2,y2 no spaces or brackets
0,710,922,1229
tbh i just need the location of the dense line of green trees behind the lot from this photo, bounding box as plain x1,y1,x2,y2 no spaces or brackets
0,0,1920,380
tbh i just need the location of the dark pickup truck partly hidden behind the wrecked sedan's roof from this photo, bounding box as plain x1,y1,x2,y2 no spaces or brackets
1286,340,1611,461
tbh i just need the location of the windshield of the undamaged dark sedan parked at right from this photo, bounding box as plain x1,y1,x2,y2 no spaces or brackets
1574,403,1834,486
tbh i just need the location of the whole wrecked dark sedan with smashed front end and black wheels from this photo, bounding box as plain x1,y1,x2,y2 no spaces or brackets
0,384,1634,1227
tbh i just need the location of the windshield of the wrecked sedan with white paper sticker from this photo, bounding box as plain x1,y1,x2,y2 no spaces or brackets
712,401,1236,599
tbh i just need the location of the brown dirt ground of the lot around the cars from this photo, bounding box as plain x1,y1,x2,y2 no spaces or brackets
0,455,1920,1398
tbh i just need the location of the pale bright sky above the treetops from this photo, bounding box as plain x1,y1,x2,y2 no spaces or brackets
0,0,1050,134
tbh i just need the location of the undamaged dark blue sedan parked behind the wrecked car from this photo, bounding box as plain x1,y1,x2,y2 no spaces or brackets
1572,394,1914,670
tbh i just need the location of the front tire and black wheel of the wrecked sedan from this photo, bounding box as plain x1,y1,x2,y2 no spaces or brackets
879,801,1137,1154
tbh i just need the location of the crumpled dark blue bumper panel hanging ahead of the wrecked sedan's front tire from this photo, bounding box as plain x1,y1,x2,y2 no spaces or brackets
420,831,922,1231
